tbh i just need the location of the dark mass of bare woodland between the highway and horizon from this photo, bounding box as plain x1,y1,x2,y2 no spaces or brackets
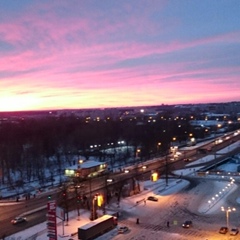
0,113,210,189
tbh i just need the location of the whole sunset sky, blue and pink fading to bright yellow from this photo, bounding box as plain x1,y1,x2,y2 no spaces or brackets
0,0,240,111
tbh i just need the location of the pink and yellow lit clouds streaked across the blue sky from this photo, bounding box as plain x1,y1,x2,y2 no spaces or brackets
0,1,240,110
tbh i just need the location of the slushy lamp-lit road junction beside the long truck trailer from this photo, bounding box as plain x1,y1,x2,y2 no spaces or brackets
98,179,239,240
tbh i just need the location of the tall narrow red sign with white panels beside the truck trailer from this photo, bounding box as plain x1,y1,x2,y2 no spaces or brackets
47,201,57,240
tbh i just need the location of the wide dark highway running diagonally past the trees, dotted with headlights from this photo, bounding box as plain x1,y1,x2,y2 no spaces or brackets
0,129,240,237
